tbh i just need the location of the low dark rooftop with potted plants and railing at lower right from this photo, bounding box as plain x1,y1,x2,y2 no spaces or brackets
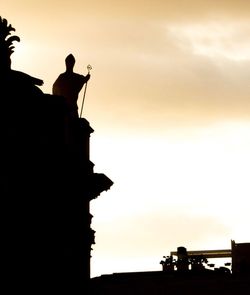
91,241,250,295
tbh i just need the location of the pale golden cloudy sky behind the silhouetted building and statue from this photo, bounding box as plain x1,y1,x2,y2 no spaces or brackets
0,0,250,276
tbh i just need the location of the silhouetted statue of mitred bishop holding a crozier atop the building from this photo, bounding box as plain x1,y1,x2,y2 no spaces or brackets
52,54,90,119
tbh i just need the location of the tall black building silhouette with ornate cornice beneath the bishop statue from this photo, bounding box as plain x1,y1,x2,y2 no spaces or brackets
0,18,113,294
